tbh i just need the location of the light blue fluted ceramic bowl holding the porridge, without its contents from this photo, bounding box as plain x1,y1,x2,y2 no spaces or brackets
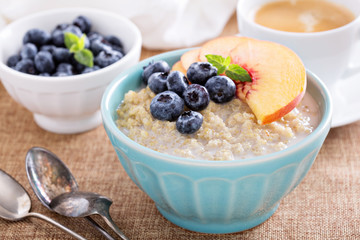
101,49,332,233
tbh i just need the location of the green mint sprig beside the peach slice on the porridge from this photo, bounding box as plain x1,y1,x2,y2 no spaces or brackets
205,54,252,82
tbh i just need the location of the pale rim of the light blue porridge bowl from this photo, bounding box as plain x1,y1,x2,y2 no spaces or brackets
101,48,333,167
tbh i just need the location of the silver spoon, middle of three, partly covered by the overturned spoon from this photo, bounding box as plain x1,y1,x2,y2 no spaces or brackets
25,147,114,240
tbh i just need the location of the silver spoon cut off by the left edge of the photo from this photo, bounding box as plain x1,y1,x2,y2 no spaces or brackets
0,169,86,240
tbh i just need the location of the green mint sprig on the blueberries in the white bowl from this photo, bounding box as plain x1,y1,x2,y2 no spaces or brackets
64,32,94,67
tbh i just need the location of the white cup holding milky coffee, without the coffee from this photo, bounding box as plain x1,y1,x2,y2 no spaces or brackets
237,0,360,91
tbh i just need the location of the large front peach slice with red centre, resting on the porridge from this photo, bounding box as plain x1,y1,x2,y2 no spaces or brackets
231,38,306,124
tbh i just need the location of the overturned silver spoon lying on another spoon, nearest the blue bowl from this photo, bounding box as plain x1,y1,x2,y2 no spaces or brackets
50,191,128,240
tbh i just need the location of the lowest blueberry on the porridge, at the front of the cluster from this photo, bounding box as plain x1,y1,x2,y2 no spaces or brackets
176,111,204,134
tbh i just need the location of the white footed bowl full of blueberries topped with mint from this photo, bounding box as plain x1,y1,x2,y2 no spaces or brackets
0,8,142,134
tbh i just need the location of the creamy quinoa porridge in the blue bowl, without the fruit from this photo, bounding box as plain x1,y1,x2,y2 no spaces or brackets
117,87,319,160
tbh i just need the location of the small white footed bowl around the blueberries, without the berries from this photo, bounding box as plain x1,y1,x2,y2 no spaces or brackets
0,8,142,134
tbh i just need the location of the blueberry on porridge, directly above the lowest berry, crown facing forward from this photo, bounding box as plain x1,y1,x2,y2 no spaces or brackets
183,83,210,111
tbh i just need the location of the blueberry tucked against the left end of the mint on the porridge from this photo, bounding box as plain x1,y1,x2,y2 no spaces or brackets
186,62,217,86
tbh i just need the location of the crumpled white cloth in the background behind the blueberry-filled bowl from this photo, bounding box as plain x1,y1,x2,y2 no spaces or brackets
0,0,237,49
